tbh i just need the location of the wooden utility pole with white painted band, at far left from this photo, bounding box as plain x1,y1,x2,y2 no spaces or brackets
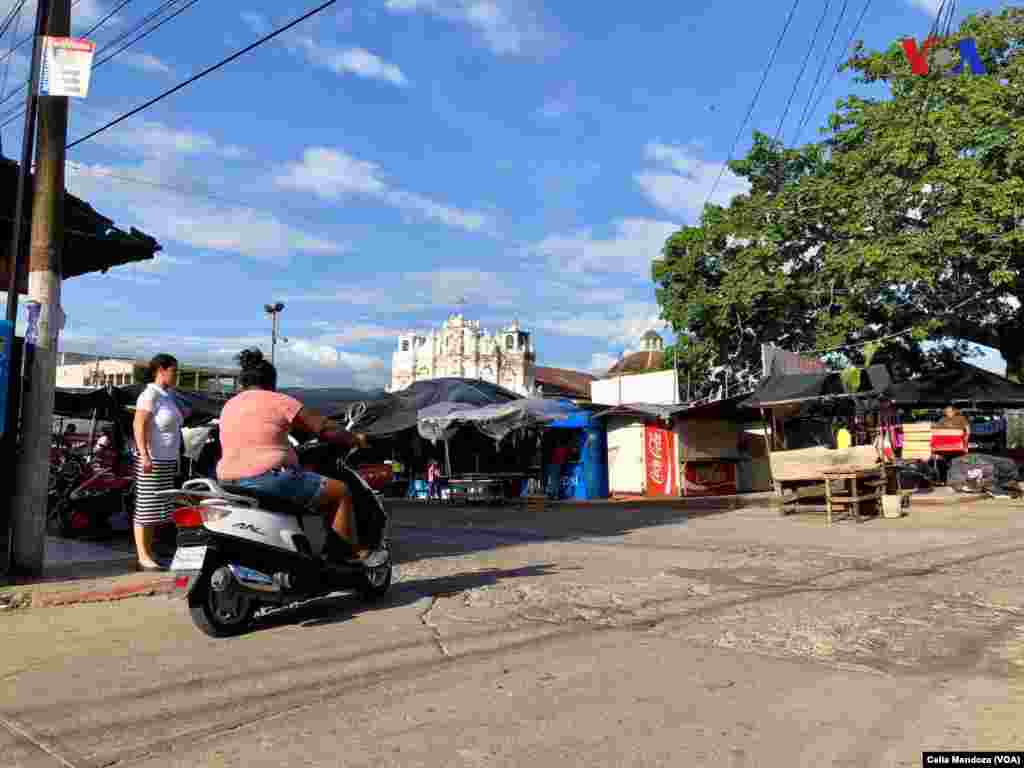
12,0,71,573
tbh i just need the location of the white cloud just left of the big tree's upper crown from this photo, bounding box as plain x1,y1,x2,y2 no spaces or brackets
634,142,750,220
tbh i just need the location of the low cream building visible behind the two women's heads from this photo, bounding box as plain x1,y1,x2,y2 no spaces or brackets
56,352,239,394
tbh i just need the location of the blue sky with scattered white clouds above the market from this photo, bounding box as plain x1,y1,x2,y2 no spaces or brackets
0,0,999,387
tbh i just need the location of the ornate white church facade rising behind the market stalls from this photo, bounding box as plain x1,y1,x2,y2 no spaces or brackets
388,314,537,395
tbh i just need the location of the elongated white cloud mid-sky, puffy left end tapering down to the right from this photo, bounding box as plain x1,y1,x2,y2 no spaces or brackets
274,146,494,232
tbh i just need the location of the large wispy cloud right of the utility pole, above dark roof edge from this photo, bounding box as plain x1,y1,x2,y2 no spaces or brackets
68,159,346,261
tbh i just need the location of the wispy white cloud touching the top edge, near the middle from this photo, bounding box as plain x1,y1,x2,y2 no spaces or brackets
386,0,545,53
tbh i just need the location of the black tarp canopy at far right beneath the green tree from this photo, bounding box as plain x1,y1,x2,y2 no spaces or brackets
886,362,1024,408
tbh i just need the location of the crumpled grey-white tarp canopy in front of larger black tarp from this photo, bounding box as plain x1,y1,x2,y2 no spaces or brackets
417,397,572,443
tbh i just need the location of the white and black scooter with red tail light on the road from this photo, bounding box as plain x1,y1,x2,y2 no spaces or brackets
164,403,394,638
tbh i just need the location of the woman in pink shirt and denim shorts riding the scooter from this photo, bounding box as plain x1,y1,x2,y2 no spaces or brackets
217,349,378,565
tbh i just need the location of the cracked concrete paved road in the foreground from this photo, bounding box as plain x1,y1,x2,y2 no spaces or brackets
0,502,1024,768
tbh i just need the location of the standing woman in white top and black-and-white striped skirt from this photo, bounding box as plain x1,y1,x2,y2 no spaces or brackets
133,354,184,570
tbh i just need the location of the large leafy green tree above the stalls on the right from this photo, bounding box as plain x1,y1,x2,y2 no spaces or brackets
653,7,1024,386
